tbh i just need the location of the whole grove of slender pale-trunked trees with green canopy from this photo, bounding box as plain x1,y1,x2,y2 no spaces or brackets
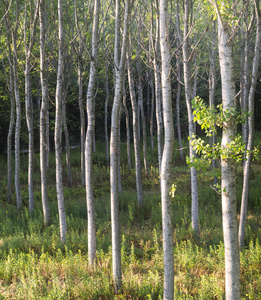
0,0,261,299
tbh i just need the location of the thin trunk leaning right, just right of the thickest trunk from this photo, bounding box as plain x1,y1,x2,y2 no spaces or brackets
239,0,261,249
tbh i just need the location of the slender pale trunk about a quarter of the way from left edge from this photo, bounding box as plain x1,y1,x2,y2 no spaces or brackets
54,0,67,243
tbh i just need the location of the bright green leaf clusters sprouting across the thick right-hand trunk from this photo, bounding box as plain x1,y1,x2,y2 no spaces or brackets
186,97,259,170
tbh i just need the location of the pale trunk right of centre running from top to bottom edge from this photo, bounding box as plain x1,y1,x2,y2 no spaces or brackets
160,0,174,300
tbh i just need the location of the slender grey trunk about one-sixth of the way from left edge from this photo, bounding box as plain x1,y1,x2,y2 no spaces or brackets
39,0,50,226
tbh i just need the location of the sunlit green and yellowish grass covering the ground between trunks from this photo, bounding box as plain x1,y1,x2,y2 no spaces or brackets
0,139,261,300
